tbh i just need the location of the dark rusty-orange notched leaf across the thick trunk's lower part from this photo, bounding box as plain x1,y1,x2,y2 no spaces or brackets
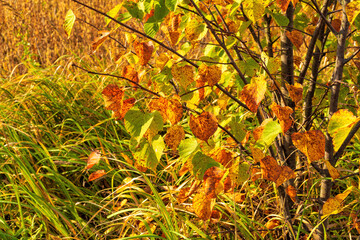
260,156,296,186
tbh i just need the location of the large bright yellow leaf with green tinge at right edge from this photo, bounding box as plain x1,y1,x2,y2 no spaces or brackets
328,109,360,151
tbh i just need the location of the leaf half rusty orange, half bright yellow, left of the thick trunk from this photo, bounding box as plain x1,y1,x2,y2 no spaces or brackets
240,77,267,112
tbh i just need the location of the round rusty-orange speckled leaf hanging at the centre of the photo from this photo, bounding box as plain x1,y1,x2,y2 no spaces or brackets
189,112,218,142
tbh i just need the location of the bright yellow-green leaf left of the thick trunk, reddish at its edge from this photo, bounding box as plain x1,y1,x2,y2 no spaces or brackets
255,119,282,148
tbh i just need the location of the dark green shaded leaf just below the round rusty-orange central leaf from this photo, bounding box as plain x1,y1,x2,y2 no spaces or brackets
191,151,220,180
